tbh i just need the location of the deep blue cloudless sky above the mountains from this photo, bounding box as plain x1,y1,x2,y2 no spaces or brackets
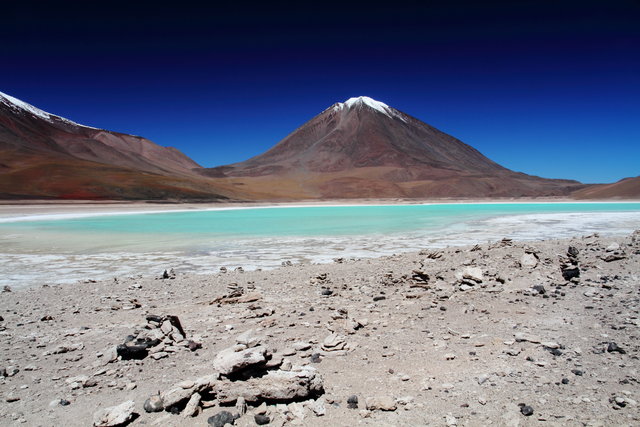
0,0,640,183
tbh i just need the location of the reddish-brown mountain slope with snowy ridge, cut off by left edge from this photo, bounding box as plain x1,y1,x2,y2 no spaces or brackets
0,92,232,199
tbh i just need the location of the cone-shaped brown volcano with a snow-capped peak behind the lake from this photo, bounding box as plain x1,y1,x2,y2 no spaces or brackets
200,96,582,199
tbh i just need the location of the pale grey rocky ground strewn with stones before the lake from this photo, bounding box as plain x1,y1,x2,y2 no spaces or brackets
0,232,640,426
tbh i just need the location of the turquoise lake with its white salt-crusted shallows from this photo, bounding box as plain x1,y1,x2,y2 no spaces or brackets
0,203,640,287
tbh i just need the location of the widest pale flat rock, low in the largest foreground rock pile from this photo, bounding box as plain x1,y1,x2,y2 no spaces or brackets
215,366,324,404
